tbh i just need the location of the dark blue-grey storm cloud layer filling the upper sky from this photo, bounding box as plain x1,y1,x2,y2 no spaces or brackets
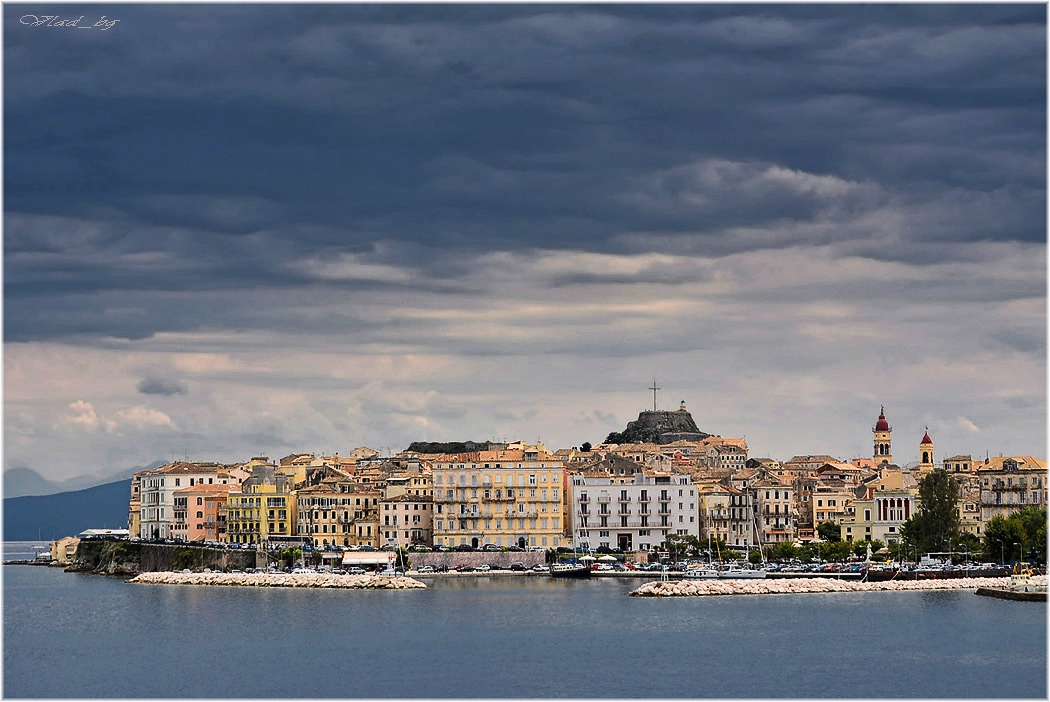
4,4,1046,339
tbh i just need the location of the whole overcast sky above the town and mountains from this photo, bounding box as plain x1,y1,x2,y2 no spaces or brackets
3,3,1047,478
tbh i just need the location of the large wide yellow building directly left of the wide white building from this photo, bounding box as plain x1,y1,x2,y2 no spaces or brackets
433,444,570,549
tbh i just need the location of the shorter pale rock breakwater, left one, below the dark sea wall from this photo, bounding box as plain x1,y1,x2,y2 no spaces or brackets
128,572,426,590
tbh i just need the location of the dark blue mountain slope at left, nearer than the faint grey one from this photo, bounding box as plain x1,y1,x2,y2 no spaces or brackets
3,480,131,541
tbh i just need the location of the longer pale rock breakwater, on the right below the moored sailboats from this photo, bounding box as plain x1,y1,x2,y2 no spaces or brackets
630,575,1047,597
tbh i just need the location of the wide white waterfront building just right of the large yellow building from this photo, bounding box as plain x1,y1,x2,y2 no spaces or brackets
570,472,699,552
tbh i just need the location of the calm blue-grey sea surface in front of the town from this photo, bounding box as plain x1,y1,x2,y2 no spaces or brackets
3,549,1047,699
